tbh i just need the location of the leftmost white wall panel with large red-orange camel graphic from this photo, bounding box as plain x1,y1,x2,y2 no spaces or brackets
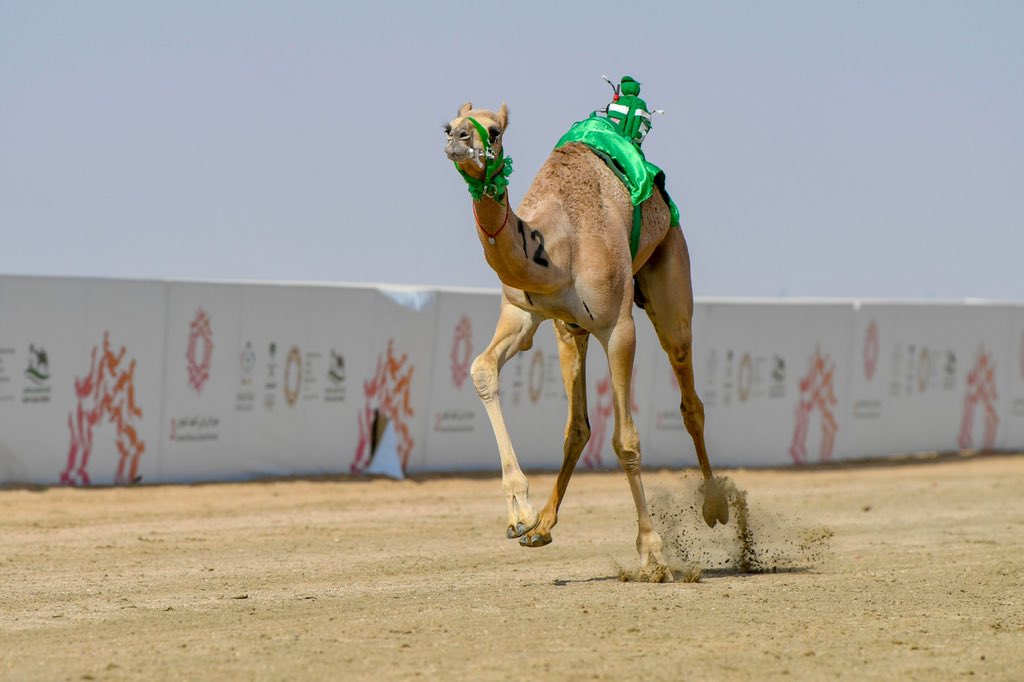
0,278,174,485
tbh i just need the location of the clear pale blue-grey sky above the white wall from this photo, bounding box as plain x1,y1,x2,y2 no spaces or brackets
0,0,1024,300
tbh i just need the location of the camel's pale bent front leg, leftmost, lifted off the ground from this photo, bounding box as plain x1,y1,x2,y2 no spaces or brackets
471,297,543,539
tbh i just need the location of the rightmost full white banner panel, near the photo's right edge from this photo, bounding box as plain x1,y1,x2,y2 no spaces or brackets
847,303,1012,457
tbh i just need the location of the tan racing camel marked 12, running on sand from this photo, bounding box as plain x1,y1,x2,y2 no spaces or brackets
444,102,729,578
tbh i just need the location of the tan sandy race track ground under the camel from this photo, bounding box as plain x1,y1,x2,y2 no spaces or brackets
0,456,1024,680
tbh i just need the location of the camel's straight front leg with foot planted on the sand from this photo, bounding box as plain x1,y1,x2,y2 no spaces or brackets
599,313,672,581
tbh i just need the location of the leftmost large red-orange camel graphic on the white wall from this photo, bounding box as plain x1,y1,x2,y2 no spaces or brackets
60,332,145,485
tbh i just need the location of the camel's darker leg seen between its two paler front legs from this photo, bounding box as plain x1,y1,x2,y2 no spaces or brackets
519,322,590,547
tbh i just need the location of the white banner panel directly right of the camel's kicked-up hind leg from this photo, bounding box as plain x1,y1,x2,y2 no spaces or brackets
647,301,853,466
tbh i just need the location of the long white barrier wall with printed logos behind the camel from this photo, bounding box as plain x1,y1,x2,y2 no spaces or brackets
0,270,1024,484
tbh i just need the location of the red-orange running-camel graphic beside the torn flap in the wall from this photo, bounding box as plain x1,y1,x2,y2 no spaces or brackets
351,339,416,473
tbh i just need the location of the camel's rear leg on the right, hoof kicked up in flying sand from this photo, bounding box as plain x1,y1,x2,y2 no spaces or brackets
635,228,729,527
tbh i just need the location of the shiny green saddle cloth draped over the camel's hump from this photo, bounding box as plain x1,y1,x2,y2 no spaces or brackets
555,114,679,258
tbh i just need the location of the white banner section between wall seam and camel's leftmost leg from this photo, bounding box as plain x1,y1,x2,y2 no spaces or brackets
424,292,501,471
